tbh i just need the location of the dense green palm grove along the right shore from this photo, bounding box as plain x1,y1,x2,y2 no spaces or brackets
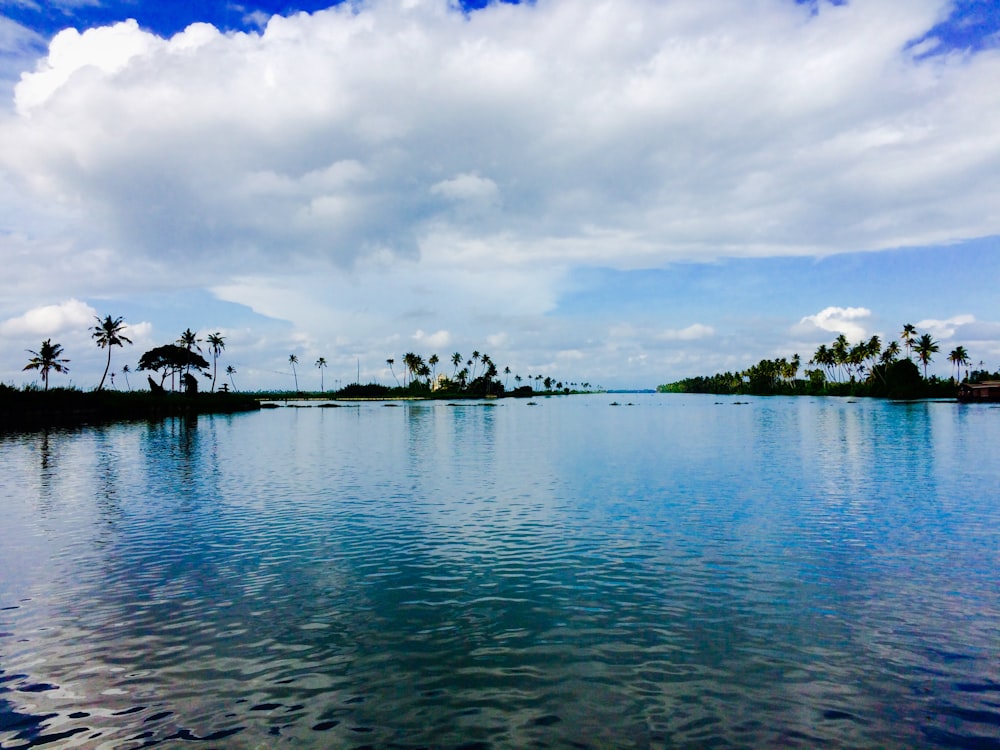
657,323,984,399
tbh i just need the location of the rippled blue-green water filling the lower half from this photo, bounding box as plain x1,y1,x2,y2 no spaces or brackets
0,395,1000,750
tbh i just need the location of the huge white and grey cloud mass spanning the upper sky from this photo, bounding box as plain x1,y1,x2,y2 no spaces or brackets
0,0,1000,288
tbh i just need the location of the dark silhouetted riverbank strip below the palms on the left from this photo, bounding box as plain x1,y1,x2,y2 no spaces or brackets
0,386,260,432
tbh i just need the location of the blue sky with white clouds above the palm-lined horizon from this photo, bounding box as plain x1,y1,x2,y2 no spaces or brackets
0,0,1000,390
